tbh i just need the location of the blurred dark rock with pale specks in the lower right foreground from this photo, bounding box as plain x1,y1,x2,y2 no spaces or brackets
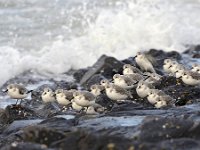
138,117,194,142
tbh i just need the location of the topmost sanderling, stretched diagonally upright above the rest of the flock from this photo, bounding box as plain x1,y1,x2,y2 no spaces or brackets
135,52,156,72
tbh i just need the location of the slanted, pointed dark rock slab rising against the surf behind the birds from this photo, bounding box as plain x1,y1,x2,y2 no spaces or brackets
80,55,124,85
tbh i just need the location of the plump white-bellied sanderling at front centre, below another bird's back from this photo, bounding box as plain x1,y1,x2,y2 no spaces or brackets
105,84,132,101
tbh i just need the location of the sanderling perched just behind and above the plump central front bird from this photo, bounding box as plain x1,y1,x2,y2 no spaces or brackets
113,74,137,89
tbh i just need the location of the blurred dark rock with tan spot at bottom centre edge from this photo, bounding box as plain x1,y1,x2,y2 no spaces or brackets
51,131,132,150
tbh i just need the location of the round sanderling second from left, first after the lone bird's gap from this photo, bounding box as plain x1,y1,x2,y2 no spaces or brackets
41,88,56,103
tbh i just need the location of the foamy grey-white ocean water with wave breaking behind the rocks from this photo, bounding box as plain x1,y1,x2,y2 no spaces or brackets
0,0,200,85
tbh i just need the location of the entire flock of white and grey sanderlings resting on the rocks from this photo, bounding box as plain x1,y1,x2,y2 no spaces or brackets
2,52,200,114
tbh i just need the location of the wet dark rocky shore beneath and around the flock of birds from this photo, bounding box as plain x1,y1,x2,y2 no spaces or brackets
0,47,200,150
